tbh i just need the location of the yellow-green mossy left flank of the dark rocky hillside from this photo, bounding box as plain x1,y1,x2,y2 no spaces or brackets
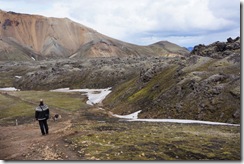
104,65,178,117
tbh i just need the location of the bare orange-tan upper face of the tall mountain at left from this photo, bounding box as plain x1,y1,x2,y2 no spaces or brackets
0,11,99,57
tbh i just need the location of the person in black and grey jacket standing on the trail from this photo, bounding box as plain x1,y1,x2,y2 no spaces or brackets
35,99,49,135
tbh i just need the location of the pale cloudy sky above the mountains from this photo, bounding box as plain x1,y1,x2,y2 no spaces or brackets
0,0,241,47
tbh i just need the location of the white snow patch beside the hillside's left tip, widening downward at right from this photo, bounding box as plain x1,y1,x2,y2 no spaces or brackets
51,87,112,105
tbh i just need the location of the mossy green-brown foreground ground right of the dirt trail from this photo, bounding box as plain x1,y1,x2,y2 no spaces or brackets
69,119,240,160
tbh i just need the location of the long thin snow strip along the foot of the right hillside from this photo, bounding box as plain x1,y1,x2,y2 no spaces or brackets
113,110,240,126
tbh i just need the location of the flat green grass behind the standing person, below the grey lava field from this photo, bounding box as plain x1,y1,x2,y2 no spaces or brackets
0,91,89,125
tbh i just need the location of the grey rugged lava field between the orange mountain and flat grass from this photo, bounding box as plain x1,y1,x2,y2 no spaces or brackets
0,57,178,90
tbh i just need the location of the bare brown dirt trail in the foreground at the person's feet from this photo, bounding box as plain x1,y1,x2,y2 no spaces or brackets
0,109,80,160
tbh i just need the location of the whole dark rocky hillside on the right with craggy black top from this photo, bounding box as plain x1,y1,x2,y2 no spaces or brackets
104,38,241,123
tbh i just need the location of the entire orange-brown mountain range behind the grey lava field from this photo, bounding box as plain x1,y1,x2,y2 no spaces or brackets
0,10,189,61
